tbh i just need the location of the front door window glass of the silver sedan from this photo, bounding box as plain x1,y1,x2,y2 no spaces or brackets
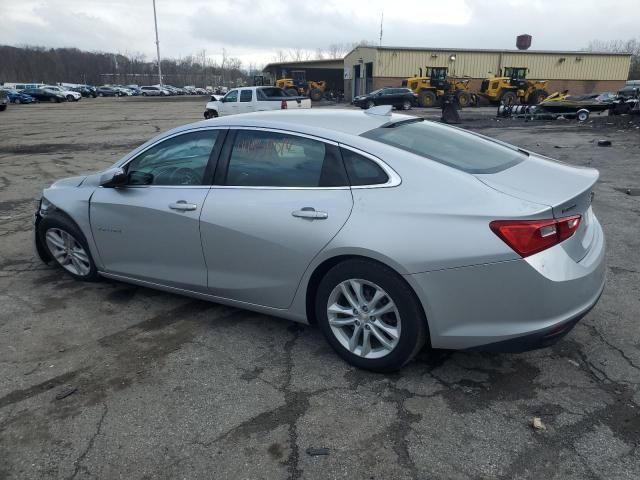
127,130,218,185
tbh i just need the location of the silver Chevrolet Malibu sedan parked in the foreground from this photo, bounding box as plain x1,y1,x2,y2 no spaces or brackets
35,107,605,371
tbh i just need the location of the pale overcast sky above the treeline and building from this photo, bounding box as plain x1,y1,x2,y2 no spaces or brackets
0,0,640,67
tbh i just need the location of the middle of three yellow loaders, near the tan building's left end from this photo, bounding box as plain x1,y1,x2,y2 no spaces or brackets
402,67,474,107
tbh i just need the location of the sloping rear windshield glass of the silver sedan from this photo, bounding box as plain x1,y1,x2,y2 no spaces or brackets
362,121,526,173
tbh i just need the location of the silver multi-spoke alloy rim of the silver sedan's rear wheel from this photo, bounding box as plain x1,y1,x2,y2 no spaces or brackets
327,279,401,359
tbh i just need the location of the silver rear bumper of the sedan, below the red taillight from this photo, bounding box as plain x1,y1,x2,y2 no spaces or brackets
407,217,606,352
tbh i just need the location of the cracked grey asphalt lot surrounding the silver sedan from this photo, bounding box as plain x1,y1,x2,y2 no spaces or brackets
0,99,640,479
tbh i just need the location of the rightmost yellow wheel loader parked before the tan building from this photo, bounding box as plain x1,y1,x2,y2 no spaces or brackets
479,67,549,106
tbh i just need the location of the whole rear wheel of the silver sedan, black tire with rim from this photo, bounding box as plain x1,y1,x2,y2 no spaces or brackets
315,260,428,372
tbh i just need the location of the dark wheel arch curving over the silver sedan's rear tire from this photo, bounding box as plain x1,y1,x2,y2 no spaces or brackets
305,253,431,343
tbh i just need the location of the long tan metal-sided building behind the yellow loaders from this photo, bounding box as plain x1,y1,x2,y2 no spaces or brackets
344,47,631,100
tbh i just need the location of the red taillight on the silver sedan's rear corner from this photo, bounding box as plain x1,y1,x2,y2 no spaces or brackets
489,215,582,257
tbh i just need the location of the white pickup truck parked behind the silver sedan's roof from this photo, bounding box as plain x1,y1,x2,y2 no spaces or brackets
204,87,311,118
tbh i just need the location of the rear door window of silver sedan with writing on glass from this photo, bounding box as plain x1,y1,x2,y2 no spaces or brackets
226,130,347,187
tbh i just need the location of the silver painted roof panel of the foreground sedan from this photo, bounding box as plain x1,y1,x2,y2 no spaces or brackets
188,108,413,138
